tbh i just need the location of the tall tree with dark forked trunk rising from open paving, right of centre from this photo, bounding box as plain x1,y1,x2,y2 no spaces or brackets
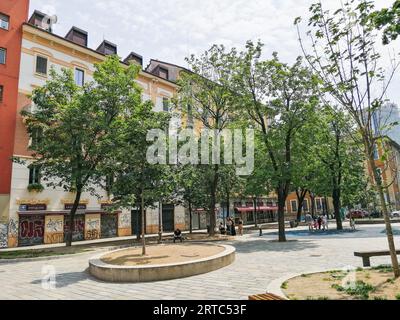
235,42,318,242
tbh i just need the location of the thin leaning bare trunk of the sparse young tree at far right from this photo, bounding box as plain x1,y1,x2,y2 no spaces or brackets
367,154,400,278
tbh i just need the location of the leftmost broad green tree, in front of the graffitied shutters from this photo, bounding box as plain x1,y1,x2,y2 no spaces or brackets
23,56,140,246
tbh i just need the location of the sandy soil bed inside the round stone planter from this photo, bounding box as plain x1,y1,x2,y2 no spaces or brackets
101,244,225,266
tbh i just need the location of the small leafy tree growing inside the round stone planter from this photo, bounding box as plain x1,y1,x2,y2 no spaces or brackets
108,102,170,255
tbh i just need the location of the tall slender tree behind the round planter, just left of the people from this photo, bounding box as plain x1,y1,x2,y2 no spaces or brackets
178,45,235,235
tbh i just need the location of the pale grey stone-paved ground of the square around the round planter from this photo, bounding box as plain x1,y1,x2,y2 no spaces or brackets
0,225,400,300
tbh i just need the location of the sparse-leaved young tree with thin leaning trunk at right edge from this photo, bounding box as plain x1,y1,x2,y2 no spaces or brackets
295,0,400,277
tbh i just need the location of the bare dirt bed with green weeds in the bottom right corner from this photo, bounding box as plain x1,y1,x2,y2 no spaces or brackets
282,266,400,300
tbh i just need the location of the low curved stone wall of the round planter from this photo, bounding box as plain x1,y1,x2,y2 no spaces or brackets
89,244,236,282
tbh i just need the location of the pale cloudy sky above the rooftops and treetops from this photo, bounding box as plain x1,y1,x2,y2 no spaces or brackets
30,0,400,104
